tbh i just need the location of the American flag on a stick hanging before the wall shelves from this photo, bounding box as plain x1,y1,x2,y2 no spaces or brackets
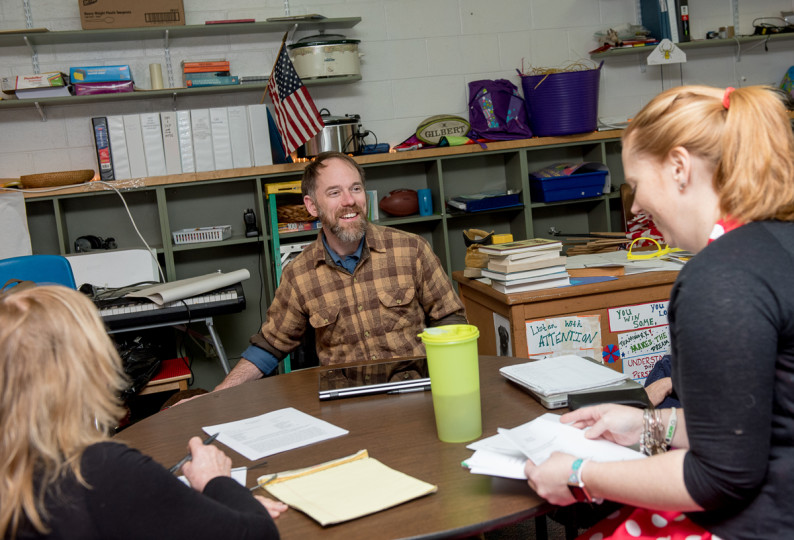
267,45,325,154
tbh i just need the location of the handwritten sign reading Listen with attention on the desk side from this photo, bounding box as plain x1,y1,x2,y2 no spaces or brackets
526,315,601,360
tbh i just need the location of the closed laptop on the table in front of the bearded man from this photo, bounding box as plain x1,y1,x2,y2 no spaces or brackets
318,358,430,400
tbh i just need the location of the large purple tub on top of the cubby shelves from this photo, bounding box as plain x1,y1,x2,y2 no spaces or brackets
521,62,603,137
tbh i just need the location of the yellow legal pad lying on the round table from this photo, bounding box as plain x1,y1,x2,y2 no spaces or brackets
257,450,438,526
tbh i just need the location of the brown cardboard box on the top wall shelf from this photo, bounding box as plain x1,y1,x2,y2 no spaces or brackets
77,0,185,30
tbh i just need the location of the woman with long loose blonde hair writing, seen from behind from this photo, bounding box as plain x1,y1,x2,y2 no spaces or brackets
0,286,286,539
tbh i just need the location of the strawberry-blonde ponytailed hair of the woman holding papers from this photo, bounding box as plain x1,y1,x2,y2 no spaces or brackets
623,86,794,222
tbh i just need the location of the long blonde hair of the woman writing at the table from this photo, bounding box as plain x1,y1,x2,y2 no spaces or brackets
0,286,127,538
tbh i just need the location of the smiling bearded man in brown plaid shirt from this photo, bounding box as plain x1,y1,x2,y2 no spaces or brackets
215,152,466,390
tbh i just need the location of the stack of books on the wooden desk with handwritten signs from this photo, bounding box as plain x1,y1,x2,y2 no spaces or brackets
480,238,570,294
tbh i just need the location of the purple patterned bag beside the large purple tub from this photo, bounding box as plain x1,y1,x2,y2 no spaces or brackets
469,79,532,141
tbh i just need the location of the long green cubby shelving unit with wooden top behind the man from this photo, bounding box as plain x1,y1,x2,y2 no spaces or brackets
17,131,623,356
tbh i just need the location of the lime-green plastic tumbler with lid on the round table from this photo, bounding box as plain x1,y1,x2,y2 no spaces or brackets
419,324,482,443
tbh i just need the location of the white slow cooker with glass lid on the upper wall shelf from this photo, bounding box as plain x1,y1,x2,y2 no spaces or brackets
287,34,361,79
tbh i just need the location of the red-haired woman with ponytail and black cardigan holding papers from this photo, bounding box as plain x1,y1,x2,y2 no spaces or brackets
526,86,794,539
